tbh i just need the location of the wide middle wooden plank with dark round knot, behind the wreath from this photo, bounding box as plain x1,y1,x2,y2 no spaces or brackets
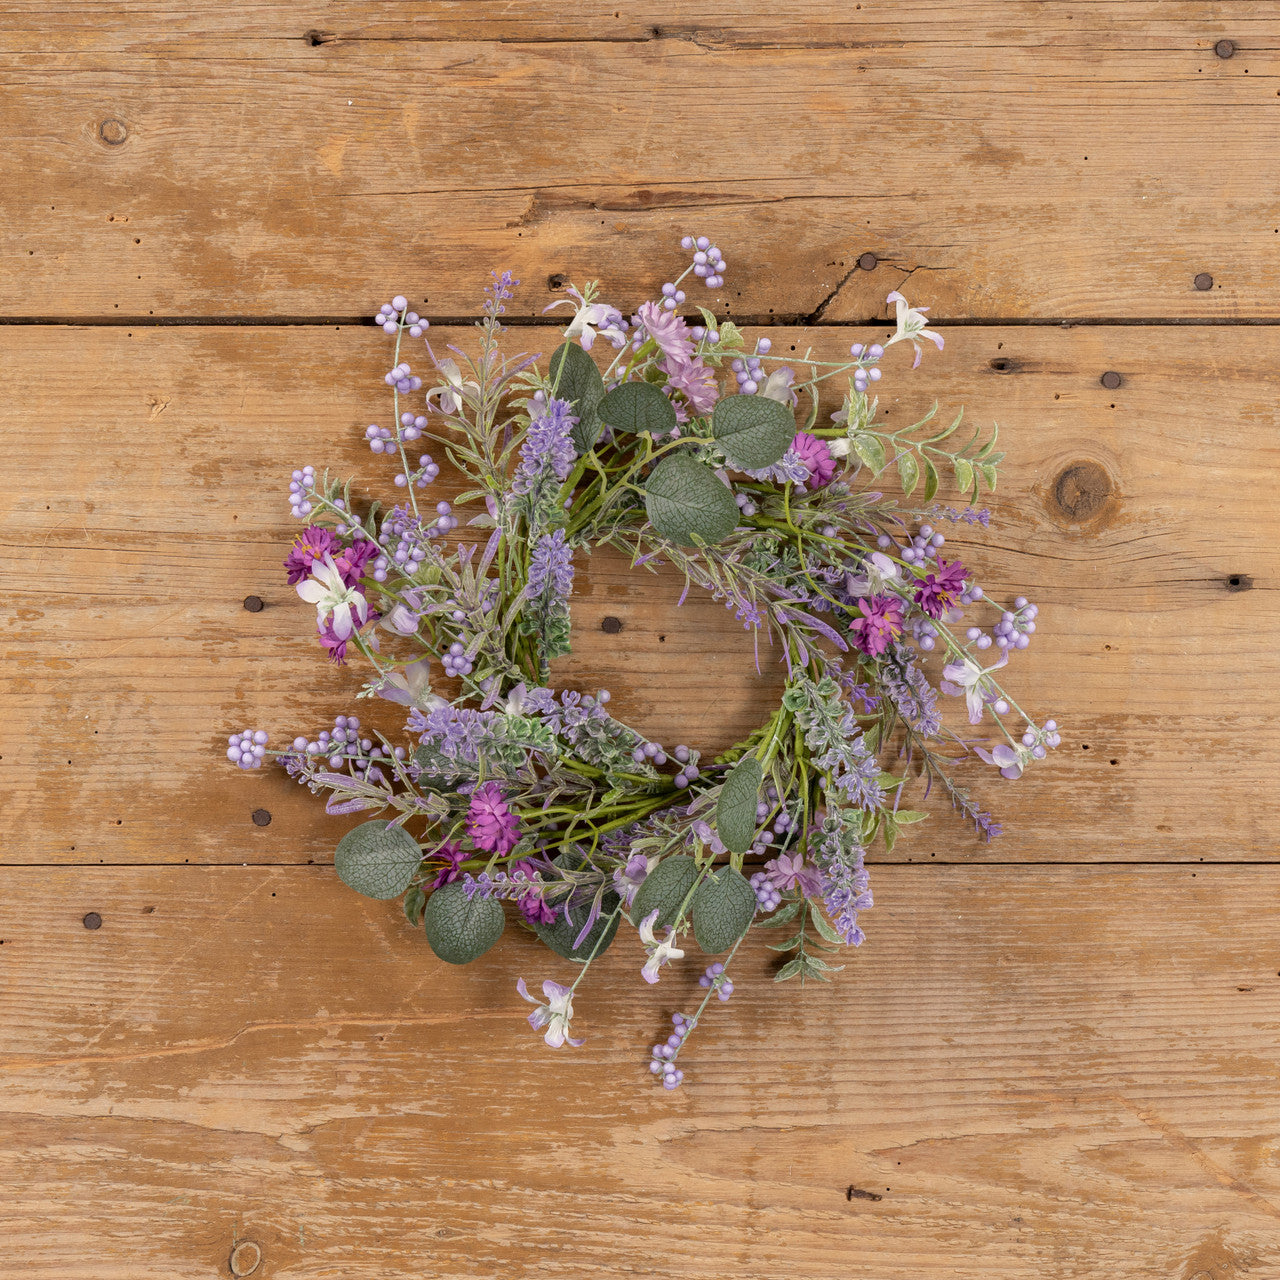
0,320,1280,863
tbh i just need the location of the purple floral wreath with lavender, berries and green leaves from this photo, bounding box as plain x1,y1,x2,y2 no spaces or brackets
227,236,1059,1088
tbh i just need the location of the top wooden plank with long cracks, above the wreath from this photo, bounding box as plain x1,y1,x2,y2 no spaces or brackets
0,0,1280,320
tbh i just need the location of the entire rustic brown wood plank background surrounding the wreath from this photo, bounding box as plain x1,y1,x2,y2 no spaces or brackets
0,0,1280,1280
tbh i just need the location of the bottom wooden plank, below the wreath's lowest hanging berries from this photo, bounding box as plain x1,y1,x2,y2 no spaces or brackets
0,867,1280,1280
